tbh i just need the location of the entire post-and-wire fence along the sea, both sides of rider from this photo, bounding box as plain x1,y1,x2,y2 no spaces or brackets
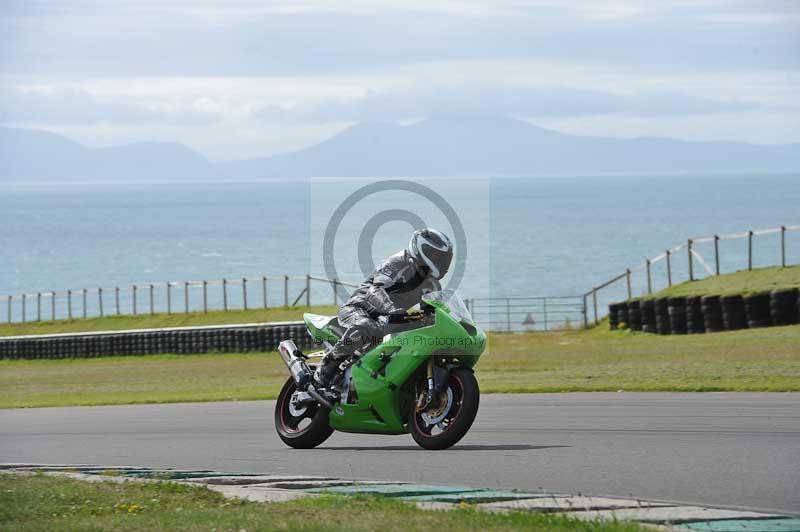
0,225,800,331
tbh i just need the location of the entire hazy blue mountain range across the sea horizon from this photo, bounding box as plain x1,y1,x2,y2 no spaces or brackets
0,117,800,181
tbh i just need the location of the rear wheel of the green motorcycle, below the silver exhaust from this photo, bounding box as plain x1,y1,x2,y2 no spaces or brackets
275,378,333,449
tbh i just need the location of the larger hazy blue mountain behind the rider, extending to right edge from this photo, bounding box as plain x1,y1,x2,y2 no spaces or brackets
226,118,800,178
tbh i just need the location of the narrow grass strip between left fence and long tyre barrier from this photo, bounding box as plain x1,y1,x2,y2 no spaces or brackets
0,305,336,336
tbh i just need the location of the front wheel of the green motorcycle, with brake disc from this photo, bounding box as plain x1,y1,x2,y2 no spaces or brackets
408,368,481,450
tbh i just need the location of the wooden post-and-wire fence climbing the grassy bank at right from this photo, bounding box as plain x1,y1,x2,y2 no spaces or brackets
583,225,800,327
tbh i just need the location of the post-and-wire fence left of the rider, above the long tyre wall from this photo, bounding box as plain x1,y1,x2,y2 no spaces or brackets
0,275,357,323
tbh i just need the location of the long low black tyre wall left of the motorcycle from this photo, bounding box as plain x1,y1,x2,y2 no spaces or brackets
0,322,314,359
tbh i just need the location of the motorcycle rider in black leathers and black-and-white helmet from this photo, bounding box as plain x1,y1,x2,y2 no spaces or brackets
314,229,453,388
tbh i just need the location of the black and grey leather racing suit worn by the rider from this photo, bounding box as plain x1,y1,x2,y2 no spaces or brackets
331,250,441,360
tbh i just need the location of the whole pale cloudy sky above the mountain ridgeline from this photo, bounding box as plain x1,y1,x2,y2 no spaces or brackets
0,0,800,160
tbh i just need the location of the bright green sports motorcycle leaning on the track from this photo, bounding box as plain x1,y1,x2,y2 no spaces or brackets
275,290,486,449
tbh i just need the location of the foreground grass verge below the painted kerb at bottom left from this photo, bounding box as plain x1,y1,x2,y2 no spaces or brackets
0,474,643,532
